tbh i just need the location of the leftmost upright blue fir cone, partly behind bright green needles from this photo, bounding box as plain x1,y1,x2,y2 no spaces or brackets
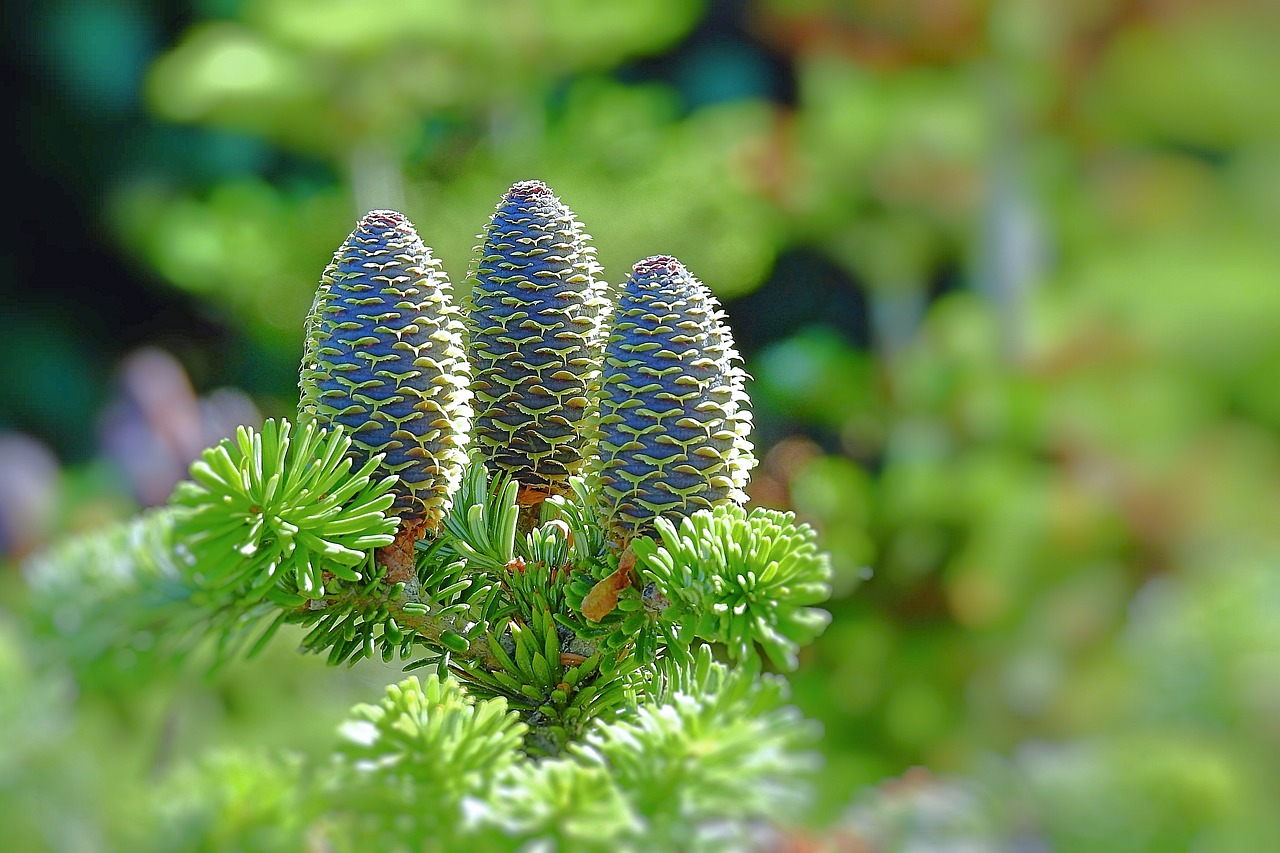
298,210,471,529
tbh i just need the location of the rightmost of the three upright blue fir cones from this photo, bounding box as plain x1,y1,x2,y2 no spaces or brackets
595,255,755,543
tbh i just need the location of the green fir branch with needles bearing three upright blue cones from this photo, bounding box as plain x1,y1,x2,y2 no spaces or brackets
20,182,831,849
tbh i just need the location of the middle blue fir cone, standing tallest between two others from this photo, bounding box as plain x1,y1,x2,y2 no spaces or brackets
470,181,608,494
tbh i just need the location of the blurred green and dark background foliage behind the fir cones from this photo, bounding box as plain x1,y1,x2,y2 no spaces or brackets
0,0,1280,850
